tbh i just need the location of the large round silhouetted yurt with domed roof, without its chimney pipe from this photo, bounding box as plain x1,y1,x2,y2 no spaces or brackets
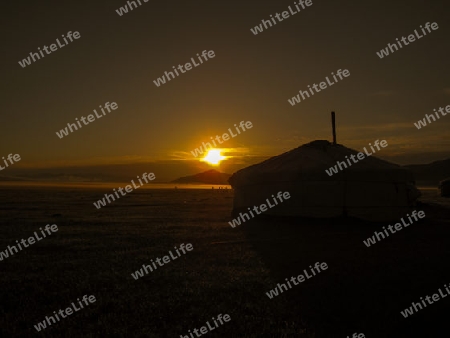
229,140,420,221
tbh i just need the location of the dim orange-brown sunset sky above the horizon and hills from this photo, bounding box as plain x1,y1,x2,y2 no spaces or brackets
0,0,450,178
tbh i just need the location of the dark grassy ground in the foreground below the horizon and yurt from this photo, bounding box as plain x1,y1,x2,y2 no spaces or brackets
0,187,450,338
